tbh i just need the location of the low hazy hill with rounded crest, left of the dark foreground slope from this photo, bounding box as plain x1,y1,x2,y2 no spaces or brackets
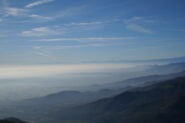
2,89,121,122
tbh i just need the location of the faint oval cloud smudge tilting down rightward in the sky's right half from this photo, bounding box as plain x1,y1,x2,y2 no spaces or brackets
127,23,152,34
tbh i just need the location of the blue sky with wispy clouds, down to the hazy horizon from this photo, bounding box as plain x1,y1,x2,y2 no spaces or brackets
0,0,185,65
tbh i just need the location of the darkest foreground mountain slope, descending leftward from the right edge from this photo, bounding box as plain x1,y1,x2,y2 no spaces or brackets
44,77,185,123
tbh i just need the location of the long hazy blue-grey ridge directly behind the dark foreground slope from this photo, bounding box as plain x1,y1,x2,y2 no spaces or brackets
2,72,185,121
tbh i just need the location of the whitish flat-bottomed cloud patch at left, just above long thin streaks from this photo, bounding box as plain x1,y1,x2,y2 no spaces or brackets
22,27,59,37
